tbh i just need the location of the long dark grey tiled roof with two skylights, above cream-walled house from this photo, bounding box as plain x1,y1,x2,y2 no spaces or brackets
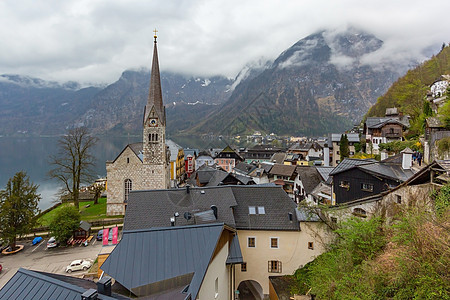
124,185,298,230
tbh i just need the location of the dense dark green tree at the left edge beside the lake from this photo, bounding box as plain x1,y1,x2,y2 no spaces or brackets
0,171,41,250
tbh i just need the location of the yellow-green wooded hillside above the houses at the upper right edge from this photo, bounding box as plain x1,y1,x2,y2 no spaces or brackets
367,46,450,120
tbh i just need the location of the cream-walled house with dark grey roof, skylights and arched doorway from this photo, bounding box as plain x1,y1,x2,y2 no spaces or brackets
119,184,329,299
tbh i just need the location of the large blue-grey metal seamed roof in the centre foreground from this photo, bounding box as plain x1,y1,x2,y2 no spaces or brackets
101,223,224,299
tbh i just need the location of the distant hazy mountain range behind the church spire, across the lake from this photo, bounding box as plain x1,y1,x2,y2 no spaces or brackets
0,70,233,135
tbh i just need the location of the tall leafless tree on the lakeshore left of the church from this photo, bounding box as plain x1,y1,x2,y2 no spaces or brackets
48,127,98,209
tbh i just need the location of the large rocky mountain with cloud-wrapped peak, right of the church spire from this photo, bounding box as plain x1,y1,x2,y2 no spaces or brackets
185,29,400,135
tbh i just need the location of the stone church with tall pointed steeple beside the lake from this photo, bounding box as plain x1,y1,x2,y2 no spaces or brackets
106,32,170,215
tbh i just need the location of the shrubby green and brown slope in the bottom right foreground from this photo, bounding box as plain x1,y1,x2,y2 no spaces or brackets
292,184,450,300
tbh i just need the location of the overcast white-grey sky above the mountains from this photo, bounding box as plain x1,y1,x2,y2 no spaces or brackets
0,0,450,84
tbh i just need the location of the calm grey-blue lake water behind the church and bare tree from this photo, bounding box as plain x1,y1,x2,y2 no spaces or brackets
0,136,224,210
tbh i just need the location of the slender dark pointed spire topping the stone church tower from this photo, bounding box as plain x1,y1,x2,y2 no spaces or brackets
144,29,166,125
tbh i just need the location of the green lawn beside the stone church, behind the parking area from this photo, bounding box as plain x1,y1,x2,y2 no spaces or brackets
38,198,123,226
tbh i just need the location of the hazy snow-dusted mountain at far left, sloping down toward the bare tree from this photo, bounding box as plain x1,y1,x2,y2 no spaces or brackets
0,75,101,135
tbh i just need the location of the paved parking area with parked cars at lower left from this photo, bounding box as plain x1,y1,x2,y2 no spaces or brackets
0,238,118,288
